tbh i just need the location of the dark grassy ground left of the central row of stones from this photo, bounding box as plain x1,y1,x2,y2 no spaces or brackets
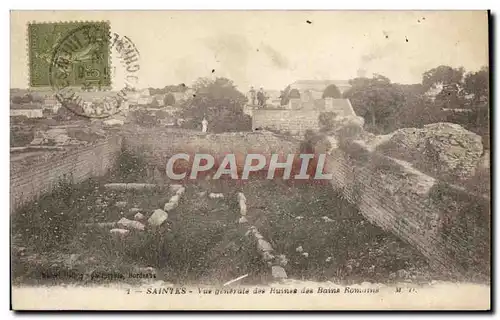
12,180,265,284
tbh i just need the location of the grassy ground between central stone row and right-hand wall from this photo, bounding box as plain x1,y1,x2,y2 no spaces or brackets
236,181,439,283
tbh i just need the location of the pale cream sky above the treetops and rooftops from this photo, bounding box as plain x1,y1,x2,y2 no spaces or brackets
10,11,488,91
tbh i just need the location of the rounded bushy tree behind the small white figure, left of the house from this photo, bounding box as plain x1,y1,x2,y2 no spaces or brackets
180,78,252,132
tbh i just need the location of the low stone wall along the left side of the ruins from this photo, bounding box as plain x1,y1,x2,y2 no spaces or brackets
10,136,122,213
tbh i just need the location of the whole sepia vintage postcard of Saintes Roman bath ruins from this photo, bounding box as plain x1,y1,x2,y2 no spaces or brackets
10,11,491,311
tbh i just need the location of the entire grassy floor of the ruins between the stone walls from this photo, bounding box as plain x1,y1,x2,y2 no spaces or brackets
12,153,437,284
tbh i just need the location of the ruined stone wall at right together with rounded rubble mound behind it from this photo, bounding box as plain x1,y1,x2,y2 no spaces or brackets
327,119,490,276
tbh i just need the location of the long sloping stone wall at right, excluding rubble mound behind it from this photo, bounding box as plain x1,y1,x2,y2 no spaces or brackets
327,143,490,279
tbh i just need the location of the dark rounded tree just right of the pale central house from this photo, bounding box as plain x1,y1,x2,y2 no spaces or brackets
344,75,405,132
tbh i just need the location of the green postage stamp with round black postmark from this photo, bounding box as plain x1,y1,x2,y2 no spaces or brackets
28,21,111,91
